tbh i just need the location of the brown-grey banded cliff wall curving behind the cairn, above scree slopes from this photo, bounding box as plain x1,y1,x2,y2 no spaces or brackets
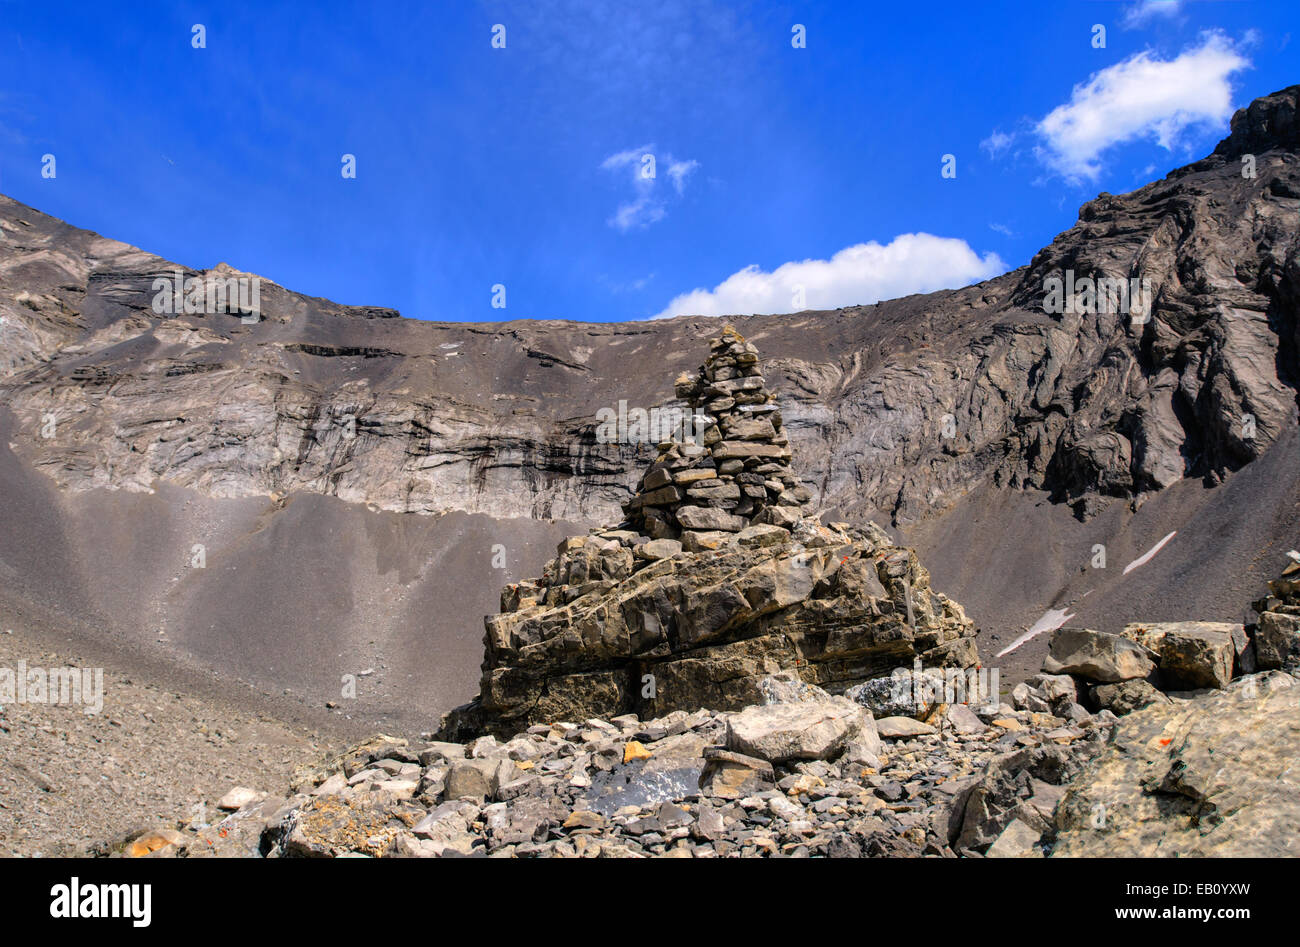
0,87,1300,723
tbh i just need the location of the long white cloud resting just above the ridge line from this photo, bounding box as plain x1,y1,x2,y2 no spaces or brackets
654,233,1008,319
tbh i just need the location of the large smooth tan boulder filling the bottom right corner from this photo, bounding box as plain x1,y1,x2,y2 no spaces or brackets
1053,671,1300,857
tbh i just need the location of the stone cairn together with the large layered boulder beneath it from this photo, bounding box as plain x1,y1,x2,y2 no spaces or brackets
441,327,978,740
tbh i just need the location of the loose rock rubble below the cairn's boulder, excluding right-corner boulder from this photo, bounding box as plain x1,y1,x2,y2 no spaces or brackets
114,674,1114,857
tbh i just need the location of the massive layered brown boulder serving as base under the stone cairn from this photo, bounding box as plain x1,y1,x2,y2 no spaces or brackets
449,489,976,739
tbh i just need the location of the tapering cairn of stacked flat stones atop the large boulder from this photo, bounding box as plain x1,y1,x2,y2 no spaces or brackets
624,325,813,543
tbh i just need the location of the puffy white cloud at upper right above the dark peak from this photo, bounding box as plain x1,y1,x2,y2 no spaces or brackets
1036,33,1251,180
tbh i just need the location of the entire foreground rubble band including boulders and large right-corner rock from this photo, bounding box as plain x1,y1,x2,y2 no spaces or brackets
106,554,1300,859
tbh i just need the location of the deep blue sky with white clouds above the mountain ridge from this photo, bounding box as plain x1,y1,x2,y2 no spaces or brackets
0,0,1300,321
